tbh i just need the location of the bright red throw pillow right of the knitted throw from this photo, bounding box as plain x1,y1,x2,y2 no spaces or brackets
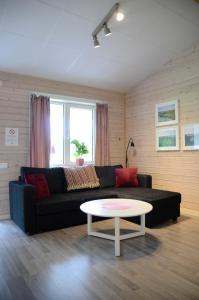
115,168,138,187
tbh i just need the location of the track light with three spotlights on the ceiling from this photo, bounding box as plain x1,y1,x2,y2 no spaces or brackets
92,2,124,48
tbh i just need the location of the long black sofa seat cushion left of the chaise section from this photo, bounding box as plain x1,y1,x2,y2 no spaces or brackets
36,189,117,215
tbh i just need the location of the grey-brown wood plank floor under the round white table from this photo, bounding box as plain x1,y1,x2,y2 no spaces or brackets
0,216,199,300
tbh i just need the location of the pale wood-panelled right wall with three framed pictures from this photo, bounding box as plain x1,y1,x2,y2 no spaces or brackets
126,46,199,210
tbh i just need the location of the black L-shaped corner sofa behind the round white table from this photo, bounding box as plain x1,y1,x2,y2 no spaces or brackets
9,166,181,235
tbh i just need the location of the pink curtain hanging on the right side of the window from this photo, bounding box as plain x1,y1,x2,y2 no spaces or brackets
95,104,110,166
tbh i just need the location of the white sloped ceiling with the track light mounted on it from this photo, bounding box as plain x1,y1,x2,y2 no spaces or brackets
0,0,199,92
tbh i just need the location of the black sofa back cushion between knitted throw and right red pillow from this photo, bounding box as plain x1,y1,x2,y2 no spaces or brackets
95,165,122,188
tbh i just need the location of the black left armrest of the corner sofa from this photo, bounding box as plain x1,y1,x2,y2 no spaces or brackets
9,181,36,234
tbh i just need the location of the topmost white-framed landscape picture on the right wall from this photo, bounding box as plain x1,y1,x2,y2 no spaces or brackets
156,100,178,126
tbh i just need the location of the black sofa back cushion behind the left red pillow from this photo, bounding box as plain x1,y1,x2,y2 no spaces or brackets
21,167,67,193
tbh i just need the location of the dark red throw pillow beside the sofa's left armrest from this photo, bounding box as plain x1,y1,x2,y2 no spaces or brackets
25,174,50,199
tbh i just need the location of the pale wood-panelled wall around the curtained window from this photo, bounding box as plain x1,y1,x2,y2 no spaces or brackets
0,72,125,218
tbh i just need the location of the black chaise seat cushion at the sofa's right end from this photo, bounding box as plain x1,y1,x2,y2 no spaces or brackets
103,187,181,207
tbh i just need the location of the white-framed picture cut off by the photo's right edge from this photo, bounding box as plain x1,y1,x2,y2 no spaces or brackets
182,124,199,150
